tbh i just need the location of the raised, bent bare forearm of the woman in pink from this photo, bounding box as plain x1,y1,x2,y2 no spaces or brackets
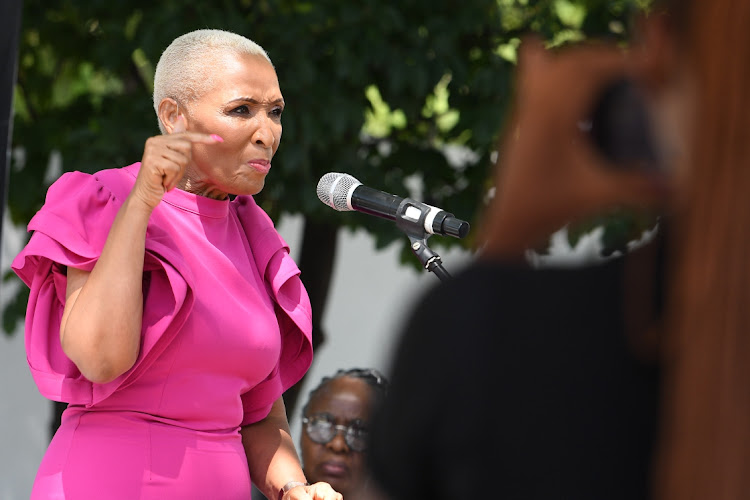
60,196,152,383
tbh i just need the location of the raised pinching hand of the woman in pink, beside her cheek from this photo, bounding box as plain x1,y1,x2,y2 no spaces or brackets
131,115,223,210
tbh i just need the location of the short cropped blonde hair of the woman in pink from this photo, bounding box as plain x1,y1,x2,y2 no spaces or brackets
154,29,273,134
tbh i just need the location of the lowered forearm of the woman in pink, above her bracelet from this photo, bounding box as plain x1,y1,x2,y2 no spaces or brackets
241,398,306,499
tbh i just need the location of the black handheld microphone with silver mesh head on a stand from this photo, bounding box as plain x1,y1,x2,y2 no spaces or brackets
317,172,470,238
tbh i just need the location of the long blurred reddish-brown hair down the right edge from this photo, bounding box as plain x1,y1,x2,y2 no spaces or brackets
654,0,750,500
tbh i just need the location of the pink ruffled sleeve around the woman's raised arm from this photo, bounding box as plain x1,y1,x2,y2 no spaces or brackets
11,169,193,406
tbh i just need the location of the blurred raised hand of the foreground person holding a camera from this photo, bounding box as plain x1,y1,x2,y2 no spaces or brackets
480,39,669,258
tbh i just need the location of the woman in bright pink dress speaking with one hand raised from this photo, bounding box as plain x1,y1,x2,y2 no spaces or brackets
12,30,342,500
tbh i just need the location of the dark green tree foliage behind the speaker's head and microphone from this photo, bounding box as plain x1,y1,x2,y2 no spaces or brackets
4,0,643,334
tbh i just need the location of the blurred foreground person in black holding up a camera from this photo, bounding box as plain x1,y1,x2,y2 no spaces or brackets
368,0,750,500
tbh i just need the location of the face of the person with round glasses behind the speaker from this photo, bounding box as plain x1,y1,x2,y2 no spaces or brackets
301,377,373,498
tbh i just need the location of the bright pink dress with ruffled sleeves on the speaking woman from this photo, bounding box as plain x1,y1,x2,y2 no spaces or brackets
12,163,312,500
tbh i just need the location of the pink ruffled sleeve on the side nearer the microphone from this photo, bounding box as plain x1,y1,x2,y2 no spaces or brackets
235,197,313,425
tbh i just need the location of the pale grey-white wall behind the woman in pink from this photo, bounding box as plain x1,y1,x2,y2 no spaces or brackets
0,214,471,500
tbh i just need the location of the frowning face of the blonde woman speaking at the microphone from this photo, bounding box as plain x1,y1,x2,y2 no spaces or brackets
180,50,284,199
